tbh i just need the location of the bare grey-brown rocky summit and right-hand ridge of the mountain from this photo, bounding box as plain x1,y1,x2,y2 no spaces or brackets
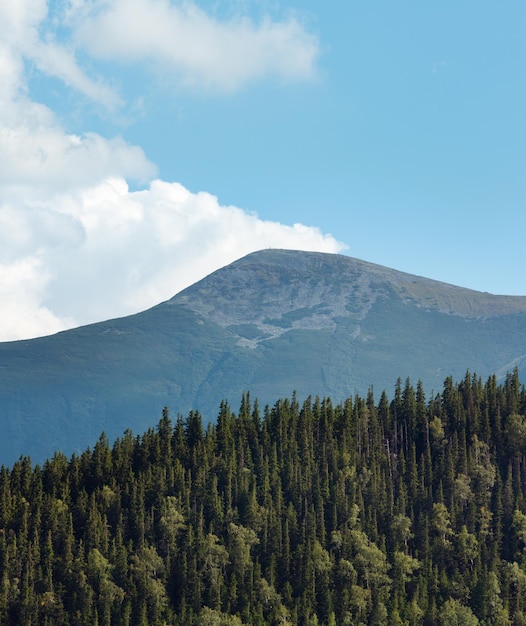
175,250,526,328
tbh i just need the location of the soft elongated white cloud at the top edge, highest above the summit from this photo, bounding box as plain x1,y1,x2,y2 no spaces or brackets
75,0,319,91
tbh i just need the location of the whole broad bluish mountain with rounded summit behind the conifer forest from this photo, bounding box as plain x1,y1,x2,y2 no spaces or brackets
0,250,526,464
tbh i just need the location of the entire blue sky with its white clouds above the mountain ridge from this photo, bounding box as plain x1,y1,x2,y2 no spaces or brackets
0,0,526,340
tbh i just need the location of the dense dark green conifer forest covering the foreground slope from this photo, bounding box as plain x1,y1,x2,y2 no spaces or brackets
0,371,526,626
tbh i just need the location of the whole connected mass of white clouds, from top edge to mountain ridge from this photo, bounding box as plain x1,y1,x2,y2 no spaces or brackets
0,0,343,341
